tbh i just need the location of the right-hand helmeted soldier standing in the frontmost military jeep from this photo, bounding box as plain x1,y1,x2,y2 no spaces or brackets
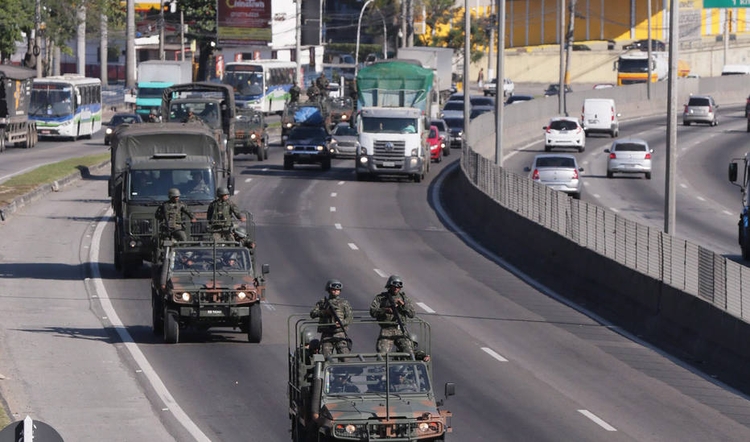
370,275,416,353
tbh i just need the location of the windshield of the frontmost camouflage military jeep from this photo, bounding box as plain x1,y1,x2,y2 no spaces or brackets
324,362,431,396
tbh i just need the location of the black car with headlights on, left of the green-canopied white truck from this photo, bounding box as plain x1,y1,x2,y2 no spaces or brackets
284,126,333,170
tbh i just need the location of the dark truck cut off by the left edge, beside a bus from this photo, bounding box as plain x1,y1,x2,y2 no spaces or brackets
0,65,39,152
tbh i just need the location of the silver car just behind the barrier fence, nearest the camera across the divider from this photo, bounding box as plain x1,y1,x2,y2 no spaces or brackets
524,154,583,199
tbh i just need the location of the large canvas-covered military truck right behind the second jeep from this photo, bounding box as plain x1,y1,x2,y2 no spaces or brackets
109,123,234,277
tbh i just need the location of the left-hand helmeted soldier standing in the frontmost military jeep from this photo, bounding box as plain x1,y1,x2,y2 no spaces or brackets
310,279,352,357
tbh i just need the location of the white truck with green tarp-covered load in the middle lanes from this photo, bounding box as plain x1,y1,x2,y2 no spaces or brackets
355,60,434,183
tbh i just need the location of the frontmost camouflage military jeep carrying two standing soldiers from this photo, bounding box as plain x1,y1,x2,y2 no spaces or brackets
287,312,455,442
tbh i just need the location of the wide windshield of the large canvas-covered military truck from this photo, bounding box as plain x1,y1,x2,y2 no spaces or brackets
128,169,216,204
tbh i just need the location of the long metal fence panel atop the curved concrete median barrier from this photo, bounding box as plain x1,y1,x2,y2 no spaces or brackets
461,147,750,322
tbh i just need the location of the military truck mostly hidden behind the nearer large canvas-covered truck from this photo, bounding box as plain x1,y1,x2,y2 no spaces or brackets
161,82,237,180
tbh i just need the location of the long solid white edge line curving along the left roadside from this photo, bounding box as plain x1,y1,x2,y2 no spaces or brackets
89,209,211,442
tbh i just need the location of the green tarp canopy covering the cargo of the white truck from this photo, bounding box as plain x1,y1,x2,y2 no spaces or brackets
357,61,434,111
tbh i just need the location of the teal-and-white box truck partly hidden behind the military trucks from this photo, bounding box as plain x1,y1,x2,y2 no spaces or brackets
135,60,193,121
